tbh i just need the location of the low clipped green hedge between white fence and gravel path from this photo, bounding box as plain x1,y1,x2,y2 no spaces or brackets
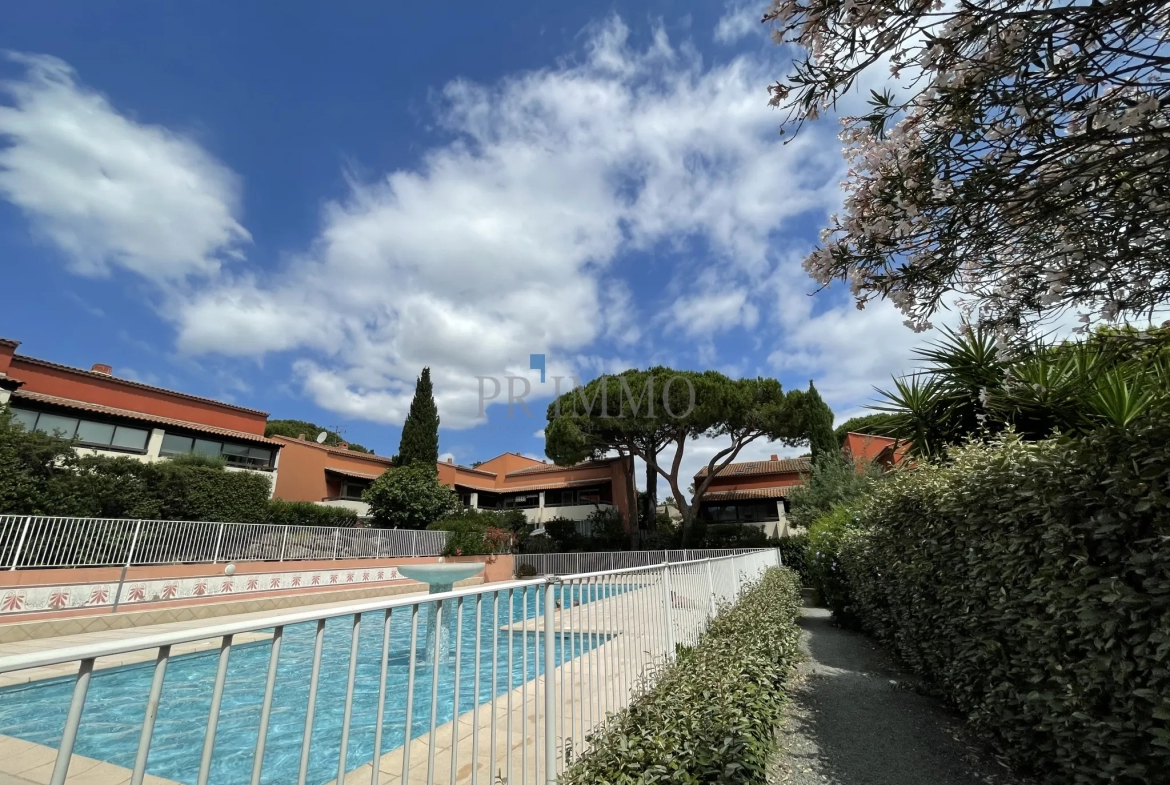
560,569,800,785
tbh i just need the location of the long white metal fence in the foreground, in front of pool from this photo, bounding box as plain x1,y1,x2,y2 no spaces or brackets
0,551,779,785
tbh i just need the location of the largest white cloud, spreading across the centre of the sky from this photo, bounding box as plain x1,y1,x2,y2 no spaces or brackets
169,18,839,427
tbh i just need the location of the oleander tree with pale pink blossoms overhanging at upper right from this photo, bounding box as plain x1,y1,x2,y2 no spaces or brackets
763,0,1170,342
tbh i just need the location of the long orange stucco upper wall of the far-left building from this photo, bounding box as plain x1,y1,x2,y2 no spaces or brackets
9,354,267,436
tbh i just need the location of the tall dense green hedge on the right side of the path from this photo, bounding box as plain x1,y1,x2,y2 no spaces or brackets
833,421,1170,785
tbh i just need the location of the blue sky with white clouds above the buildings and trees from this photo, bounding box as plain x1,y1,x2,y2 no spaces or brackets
0,0,921,481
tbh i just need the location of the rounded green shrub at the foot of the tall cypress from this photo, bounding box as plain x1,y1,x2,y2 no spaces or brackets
364,463,462,529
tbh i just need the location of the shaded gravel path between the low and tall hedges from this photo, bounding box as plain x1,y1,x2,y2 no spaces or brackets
769,607,1020,785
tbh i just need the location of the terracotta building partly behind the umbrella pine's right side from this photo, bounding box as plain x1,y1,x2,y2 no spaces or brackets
695,455,812,537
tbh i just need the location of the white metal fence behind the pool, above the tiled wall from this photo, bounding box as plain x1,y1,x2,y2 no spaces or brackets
0,515,449,570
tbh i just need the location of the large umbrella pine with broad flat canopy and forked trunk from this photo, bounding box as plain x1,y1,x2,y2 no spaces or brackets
545,366,810,545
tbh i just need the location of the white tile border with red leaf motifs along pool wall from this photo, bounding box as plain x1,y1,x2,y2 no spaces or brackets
0,567,402,619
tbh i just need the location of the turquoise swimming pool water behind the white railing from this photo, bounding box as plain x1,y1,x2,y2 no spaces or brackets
0,587,620,785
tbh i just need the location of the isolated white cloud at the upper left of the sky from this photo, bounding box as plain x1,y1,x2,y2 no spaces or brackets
0,55,249,282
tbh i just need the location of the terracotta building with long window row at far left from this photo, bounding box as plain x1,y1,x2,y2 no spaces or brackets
0,338,281,486
